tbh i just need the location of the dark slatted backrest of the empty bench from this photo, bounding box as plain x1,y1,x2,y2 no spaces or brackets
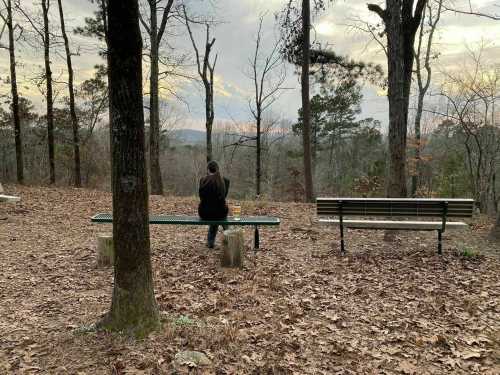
316,198,474,217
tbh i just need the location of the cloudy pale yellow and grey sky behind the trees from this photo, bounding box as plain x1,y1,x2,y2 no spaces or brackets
0,0,500,129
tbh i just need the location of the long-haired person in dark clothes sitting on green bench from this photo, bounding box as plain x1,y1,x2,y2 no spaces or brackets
198,161,229,249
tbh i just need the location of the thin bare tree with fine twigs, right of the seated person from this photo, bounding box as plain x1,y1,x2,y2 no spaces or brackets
248,15,286,196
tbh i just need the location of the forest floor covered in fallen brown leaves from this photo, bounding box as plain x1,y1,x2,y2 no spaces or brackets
0,185,500,374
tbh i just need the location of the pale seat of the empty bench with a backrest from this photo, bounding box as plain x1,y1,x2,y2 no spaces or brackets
319,219,468,230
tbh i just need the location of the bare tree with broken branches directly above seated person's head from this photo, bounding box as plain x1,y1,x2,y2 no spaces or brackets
182,6,218,162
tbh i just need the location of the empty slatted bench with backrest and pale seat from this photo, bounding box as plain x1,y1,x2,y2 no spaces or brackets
316,198,474,254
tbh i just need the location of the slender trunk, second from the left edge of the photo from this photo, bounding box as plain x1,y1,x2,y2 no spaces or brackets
42,0,56,184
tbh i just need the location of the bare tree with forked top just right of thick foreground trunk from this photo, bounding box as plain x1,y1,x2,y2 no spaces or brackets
140,0,174,194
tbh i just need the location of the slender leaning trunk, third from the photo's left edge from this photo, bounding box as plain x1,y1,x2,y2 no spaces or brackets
57,0,82,188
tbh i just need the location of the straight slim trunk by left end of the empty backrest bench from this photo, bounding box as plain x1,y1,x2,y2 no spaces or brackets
301,0,314,202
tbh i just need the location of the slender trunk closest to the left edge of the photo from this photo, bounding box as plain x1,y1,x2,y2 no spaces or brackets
7,0,24,184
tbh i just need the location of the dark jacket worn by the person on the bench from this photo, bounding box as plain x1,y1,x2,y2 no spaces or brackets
198,175,229,220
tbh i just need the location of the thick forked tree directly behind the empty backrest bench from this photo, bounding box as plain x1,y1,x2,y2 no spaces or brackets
368,0,427,197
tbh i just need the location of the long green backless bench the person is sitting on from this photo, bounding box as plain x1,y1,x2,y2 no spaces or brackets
91,213,280,249
